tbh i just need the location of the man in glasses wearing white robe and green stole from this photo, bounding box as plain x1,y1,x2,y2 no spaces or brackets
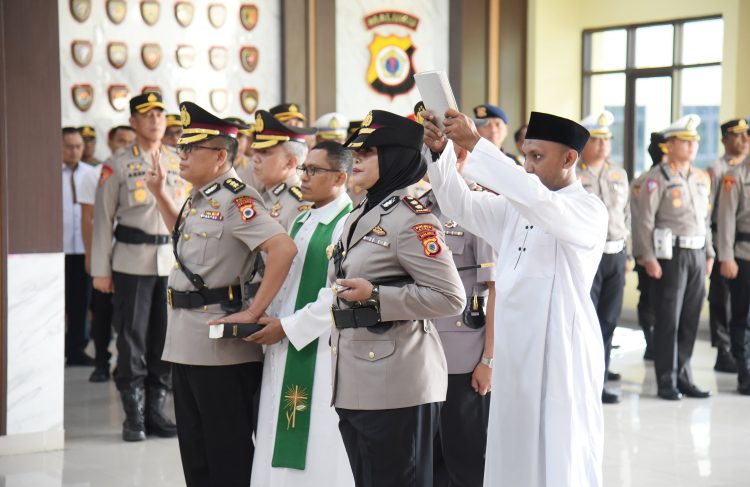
247,142,354,487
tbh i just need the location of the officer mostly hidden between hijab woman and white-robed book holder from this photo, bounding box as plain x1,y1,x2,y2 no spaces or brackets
418,141,497,487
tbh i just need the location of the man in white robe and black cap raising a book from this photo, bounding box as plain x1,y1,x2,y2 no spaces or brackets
425,110,607,487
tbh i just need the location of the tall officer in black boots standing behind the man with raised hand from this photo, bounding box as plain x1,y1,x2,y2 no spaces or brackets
91,93,187,441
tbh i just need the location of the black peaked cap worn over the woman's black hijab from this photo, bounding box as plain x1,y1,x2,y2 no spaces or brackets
344,110,424,150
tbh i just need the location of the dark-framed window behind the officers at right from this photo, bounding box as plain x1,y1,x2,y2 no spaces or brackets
582,17,724,177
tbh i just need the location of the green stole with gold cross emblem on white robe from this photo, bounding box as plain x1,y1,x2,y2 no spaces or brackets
271,204,352,470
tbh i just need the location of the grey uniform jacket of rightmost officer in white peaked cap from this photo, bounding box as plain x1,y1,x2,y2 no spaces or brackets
636,162,714,261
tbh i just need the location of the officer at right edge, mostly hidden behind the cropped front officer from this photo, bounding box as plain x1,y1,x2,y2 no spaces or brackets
708,118,748,373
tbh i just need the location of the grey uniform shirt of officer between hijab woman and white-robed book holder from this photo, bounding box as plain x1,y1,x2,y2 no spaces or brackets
421,186,497,374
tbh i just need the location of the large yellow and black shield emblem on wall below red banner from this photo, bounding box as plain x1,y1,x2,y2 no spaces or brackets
367,34,416,98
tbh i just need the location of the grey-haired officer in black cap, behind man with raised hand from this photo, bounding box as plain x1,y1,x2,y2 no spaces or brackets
251,110,315,228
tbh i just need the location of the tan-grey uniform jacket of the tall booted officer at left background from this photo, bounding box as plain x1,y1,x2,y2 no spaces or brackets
91,144,190,277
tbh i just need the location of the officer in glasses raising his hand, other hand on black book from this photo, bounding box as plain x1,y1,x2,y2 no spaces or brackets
148,102,297,486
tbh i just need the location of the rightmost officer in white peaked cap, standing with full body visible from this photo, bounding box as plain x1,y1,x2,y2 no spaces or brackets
636,115,714,400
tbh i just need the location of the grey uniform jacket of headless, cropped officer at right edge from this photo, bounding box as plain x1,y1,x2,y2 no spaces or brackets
716,157,750,261
